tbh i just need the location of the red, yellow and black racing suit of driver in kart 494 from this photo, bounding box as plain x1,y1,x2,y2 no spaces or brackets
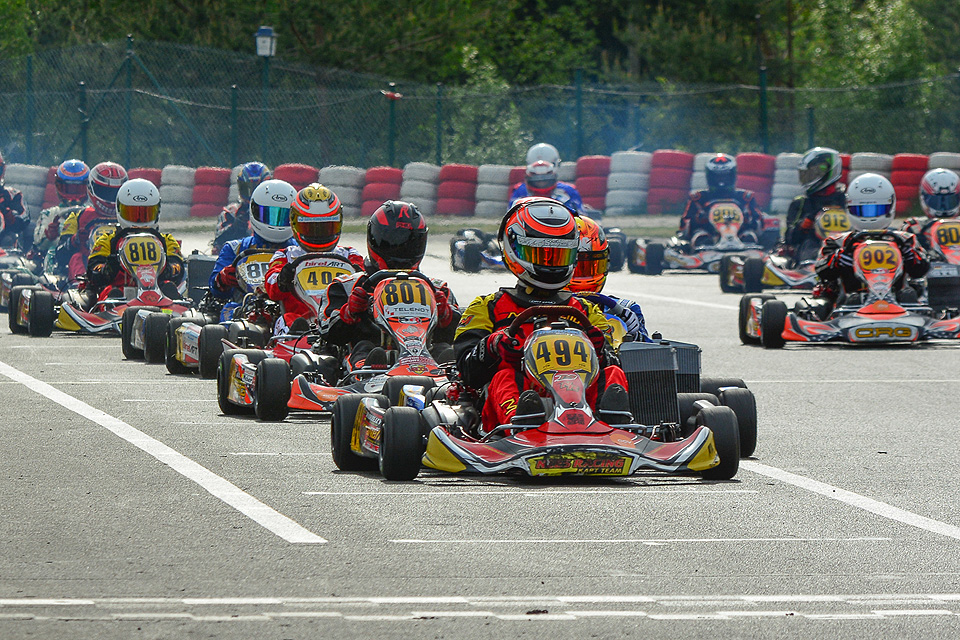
453,285,627,431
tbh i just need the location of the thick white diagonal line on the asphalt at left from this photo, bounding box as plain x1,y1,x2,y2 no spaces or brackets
0,362,326,544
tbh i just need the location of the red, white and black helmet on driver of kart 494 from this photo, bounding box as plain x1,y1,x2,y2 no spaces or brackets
497,197,580,291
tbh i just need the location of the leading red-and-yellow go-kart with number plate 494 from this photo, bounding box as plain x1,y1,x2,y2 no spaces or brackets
331,306,752,480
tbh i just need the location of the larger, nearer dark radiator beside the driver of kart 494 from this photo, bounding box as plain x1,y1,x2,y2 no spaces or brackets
620,342,684,425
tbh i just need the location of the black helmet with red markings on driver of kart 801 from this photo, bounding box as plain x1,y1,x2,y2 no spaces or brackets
367,200,428,269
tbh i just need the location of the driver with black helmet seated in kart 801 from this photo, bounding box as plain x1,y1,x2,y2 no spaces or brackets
320,200,460,367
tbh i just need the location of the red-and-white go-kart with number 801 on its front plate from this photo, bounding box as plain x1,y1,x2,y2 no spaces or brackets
236,271,447,420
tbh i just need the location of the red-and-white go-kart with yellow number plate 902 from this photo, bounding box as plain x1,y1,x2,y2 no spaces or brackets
738,231,960,349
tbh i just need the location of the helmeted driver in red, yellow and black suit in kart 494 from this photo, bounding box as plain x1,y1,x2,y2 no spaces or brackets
453,198,633,432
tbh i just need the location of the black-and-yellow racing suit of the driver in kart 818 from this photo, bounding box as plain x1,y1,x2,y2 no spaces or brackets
87,227,183,300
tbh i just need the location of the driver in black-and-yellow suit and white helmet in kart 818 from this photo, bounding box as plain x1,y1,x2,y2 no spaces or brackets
87,178,183,300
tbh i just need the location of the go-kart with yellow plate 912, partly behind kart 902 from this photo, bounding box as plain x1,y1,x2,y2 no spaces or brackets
720,207,850,293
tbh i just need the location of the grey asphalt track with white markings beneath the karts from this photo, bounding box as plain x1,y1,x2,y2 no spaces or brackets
0,231,960,638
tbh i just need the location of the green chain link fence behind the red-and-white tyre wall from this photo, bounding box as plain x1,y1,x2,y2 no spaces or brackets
0,41,960,172
